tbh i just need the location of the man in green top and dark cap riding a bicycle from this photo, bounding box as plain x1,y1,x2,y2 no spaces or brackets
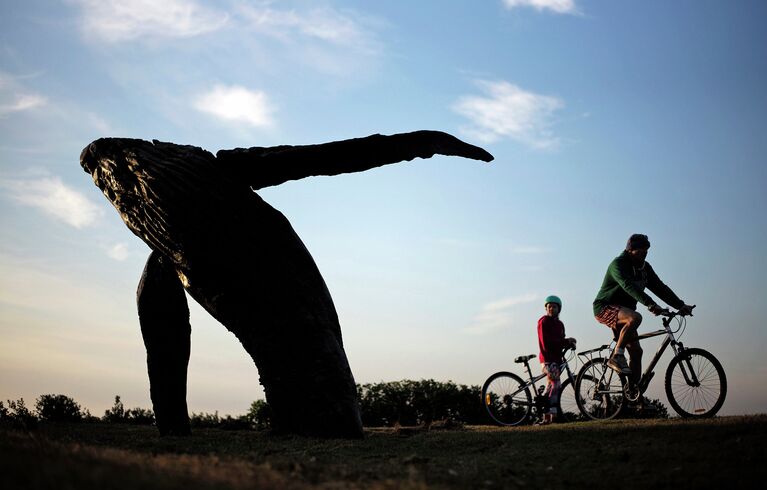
594,234,693,390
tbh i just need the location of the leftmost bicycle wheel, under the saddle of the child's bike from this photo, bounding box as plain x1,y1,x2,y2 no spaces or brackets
482,371,533,425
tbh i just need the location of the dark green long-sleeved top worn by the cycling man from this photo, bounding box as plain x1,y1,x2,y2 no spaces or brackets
594,251,684,315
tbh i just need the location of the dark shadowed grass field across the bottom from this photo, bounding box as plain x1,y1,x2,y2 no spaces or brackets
0,415,767,490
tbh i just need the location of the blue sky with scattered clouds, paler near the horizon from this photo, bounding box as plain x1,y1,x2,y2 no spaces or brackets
0,0,767,415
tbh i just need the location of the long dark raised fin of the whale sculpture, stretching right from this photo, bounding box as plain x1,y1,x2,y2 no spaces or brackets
216,130,493,189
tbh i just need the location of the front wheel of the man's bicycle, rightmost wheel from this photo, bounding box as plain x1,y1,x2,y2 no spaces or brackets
666,347,727,418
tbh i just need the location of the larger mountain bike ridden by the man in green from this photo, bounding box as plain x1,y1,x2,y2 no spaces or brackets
575,307,727,420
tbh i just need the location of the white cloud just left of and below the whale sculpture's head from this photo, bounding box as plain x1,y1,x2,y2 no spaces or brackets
0,177,103,228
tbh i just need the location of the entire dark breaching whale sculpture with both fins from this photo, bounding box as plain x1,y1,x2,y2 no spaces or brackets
80,131,493,438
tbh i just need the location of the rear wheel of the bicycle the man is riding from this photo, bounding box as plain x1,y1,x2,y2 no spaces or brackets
575,357,626,420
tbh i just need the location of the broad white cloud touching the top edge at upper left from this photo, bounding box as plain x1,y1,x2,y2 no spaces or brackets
69,0,228,42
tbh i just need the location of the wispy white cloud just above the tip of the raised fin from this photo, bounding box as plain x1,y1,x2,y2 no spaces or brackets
452,80,564,149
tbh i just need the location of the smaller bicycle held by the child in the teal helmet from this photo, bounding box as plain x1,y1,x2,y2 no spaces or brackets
482,347,580,426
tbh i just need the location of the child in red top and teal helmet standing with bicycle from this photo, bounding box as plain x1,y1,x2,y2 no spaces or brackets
538,296,575,424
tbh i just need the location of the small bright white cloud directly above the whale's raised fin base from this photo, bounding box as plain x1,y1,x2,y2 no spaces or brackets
194,85,274,127
